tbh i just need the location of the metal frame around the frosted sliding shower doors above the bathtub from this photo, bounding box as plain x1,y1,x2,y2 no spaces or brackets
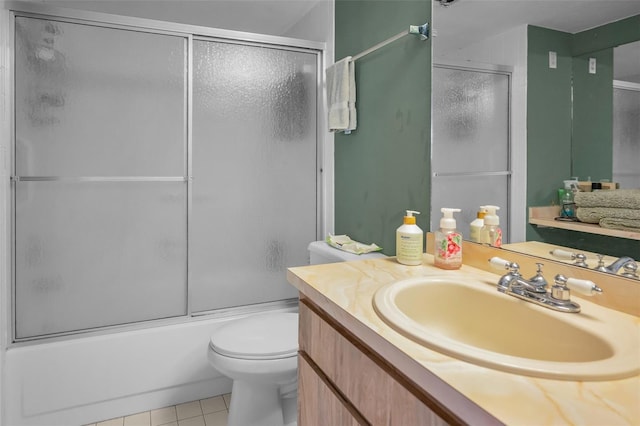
0,2,333,342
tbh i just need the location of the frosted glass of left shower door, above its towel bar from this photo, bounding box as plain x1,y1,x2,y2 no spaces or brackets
15,17,186,176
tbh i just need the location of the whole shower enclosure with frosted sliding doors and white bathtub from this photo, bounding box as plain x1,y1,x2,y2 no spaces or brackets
0,2,329,426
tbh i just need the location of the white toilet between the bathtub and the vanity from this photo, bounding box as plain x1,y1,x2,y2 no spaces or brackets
208,241,385,426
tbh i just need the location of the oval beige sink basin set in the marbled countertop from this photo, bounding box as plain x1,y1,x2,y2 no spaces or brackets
373,272,640,381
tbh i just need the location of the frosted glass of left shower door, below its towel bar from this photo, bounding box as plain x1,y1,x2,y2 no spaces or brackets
15,182,187,338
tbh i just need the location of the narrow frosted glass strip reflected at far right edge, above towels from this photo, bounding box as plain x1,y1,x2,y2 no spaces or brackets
613,88,640,188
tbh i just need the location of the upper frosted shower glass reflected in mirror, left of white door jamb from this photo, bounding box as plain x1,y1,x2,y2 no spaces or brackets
432,67,509,173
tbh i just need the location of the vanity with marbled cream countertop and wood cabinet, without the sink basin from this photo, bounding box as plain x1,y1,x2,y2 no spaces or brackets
287,244,640,425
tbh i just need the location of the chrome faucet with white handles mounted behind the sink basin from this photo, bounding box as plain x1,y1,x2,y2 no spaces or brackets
489,257,602,313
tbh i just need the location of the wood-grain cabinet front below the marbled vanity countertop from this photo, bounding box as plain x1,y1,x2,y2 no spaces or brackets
298,298,462,426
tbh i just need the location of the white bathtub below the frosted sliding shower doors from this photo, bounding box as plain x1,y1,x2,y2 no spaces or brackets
3,302,292,426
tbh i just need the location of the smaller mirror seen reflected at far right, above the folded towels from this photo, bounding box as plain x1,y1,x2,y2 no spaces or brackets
571,33,640,188
